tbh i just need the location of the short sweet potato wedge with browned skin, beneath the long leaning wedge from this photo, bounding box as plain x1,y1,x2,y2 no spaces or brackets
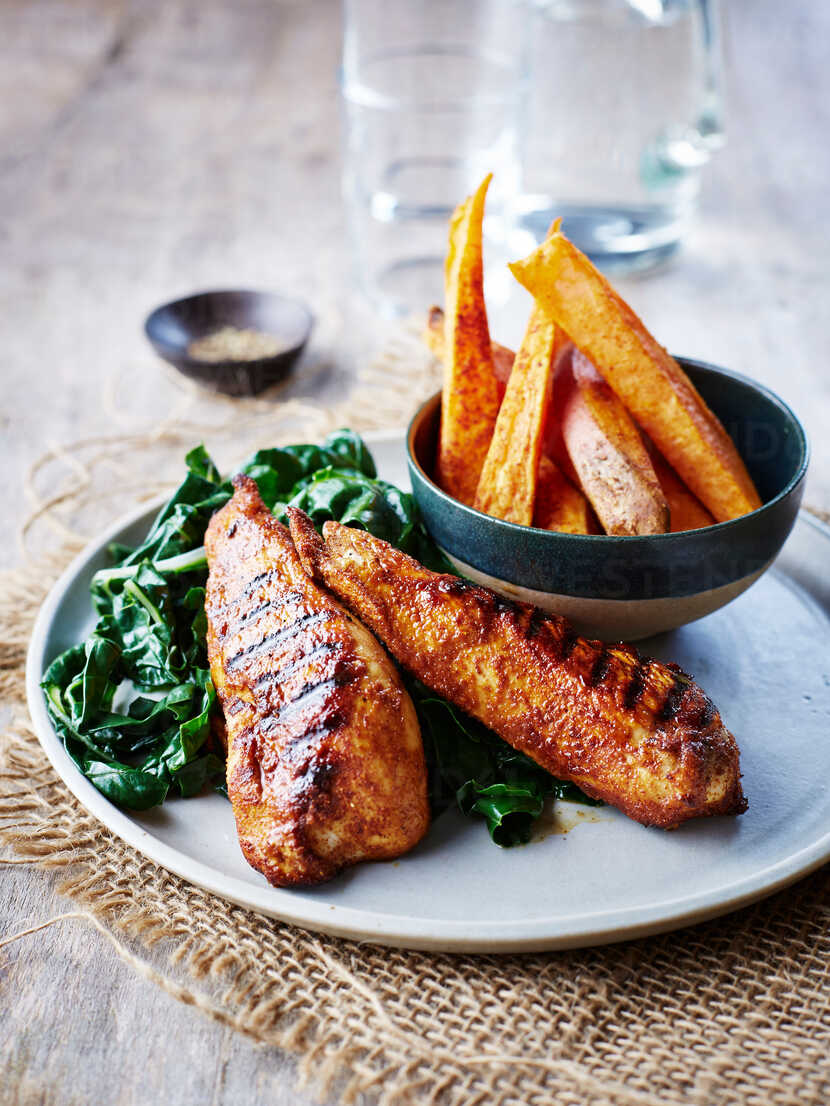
558,349,670,534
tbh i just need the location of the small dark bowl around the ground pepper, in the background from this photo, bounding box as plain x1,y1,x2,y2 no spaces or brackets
144,291,313,396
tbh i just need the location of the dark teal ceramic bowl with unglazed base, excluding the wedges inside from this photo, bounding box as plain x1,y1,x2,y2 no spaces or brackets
407,357,809,639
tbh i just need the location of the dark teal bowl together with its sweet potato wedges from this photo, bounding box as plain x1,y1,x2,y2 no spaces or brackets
407,178,808,639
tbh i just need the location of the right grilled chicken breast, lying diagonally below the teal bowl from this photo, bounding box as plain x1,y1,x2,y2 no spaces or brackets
289,510,746,828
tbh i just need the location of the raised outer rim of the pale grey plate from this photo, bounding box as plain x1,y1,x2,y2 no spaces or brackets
25,429,830,953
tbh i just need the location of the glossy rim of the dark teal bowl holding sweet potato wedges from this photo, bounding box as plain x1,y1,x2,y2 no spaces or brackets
406,354,810,549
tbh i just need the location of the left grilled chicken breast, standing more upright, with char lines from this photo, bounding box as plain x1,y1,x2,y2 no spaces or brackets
205,477,429,887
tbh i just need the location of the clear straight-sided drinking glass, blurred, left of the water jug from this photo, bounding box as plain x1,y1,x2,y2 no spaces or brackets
342,0,530,316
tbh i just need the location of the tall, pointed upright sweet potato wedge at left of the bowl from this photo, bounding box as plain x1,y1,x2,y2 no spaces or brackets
436,176,499,504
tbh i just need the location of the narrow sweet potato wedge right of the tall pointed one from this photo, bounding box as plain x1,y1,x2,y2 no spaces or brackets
473,307,557,526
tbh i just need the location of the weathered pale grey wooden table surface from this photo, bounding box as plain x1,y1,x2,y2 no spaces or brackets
0,0,830,1106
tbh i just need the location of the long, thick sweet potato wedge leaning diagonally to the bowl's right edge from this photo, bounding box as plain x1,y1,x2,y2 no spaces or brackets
510,230,760,521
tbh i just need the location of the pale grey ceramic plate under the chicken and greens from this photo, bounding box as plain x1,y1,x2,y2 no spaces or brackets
22,432,830,951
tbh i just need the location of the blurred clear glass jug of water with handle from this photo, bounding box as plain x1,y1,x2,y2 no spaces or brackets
521,0,724,272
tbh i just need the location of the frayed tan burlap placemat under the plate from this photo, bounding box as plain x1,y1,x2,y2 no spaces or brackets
0,338,830,1106
